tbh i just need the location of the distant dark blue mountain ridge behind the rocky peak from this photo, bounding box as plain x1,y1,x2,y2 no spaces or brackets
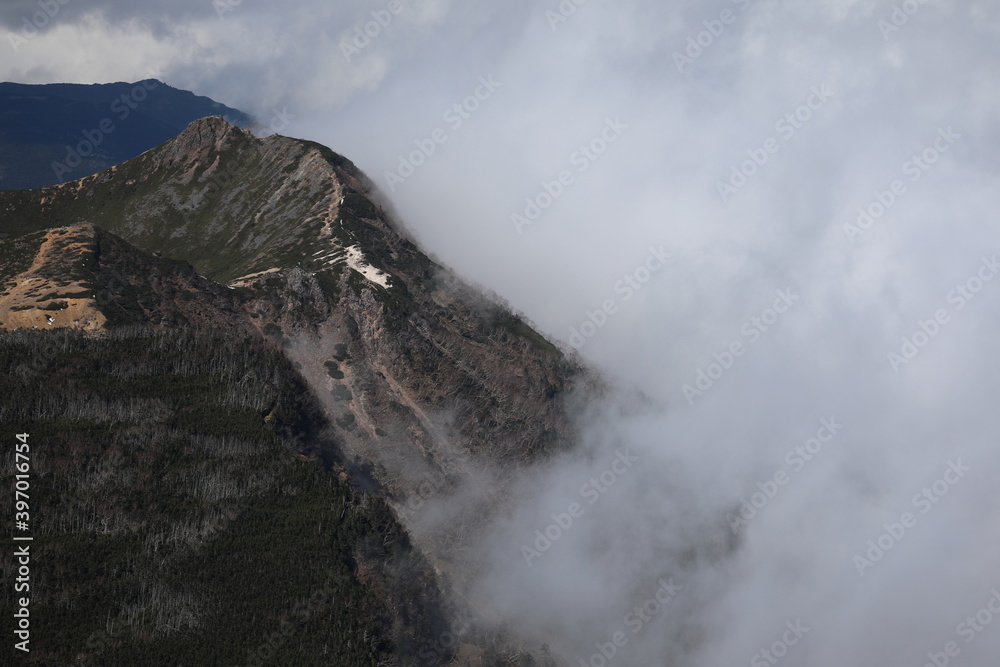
0,79,253,190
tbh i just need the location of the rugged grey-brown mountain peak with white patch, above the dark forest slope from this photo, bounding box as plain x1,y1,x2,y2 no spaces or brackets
0,118,599,636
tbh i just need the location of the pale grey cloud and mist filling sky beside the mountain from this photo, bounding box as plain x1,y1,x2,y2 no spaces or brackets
0,0,1000,667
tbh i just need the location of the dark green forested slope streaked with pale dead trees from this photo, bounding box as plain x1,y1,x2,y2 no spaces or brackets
0,327,447,666
